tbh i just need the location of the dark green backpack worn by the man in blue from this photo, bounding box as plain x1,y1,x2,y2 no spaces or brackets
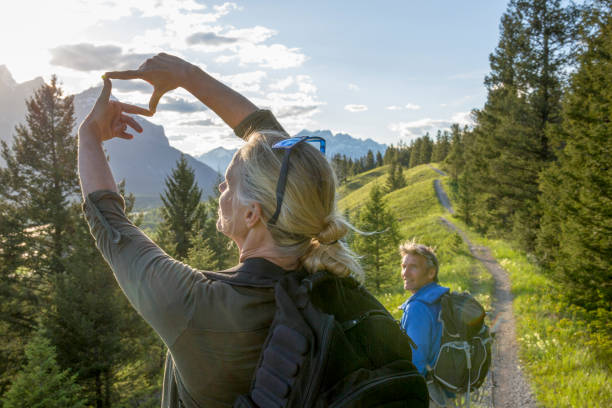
430,292,491,403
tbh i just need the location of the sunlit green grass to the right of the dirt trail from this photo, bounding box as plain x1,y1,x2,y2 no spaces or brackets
445,186,612,408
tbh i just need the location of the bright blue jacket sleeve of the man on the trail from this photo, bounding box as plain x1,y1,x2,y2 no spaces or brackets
402,301,433,376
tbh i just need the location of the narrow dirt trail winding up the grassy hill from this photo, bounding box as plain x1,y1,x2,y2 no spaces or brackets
432,173,537,408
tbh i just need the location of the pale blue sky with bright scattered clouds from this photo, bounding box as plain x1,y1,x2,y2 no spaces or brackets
0,0,507,155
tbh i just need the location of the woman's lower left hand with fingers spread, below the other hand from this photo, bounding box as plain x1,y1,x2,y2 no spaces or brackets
79,76,152,142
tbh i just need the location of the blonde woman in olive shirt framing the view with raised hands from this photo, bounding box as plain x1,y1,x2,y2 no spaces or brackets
78,54,361,407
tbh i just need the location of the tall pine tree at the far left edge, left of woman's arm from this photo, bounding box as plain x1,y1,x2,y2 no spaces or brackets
0,76,80,391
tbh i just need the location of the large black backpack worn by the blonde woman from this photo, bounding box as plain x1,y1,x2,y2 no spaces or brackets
208,271,429,408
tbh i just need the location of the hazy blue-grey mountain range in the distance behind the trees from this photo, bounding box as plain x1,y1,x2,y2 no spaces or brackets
0,65,387,208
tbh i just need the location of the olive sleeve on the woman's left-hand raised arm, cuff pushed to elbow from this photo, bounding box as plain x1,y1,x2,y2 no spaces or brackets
83,190,200,347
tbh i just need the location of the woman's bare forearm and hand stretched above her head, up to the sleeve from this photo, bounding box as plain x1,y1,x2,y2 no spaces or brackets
106,53,257,129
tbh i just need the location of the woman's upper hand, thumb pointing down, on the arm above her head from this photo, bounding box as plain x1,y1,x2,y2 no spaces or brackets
105,52,194,114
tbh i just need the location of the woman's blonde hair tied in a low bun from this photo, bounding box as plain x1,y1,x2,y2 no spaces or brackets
234,130,363,278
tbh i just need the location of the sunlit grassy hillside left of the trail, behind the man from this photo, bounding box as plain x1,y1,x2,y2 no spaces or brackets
339,165,493,318
